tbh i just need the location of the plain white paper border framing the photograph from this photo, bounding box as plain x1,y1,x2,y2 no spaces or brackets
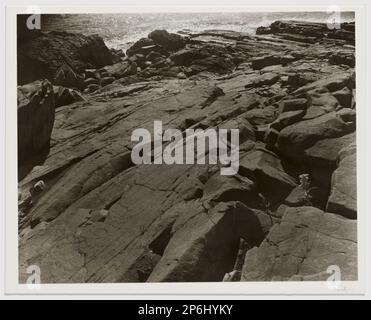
4,5,371,297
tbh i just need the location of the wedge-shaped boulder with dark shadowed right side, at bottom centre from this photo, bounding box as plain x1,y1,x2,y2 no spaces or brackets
148,202,263,282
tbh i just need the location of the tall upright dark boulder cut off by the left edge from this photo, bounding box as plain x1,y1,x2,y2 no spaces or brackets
17,81,55,163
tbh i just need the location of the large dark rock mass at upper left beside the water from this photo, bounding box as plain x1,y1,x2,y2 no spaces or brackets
17,30,117,84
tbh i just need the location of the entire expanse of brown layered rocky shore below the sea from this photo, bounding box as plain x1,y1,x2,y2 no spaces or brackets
18,21,357,283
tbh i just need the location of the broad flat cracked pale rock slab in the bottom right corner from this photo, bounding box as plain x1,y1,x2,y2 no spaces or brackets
241,207,358,281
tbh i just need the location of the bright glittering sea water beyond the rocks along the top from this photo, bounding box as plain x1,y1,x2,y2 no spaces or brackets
41,12,354,49
